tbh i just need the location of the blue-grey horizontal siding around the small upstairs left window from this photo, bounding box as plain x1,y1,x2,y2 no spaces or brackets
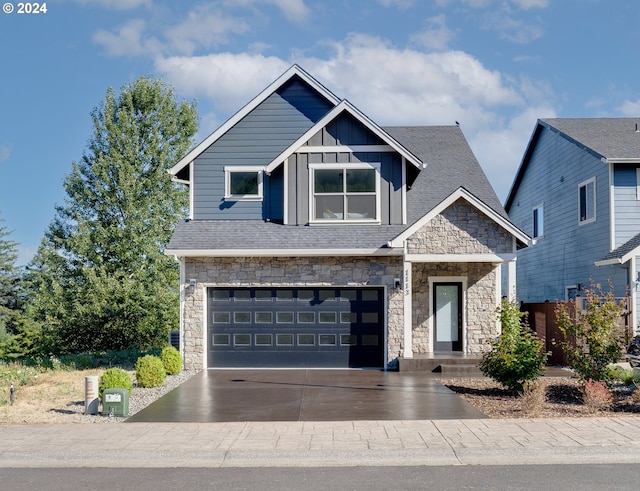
192,79,332,220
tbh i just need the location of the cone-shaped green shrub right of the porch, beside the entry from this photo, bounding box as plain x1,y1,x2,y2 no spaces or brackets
480,300,548,393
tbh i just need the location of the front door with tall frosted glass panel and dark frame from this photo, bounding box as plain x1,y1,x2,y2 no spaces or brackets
433,283,462,351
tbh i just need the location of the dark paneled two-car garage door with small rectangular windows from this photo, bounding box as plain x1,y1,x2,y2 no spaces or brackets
208,288,384,368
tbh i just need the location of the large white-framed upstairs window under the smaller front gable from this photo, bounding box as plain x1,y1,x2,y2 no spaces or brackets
309,163,380,222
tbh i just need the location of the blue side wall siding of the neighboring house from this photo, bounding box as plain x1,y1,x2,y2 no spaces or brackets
509,128,626,302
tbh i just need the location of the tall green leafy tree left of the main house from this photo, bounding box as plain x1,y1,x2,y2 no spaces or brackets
29,77,197,352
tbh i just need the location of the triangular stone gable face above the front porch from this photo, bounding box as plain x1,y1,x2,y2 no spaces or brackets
407,199,515,254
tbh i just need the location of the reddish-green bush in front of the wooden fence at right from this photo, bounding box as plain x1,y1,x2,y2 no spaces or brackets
556,284,624,381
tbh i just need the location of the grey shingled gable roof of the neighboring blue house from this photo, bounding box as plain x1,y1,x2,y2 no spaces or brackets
504,118,640,211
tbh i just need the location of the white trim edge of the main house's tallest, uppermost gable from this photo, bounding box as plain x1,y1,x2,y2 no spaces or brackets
169,65,340,176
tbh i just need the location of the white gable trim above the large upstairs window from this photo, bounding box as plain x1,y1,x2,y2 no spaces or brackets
265,100,426,172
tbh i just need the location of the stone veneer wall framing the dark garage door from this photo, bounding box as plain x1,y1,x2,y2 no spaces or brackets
182,256,404,370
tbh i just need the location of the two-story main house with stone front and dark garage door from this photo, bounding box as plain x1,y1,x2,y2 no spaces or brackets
165,65,529,369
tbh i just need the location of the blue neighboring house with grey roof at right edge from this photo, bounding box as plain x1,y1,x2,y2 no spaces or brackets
505,118,640,330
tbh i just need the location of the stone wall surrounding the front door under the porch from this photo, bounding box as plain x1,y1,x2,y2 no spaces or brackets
412,263,498,355
